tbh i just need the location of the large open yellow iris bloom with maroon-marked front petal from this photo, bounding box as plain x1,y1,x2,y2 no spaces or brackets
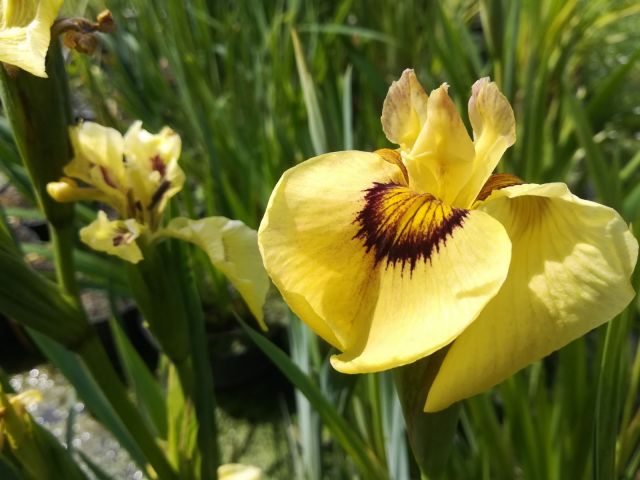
258,70,638,411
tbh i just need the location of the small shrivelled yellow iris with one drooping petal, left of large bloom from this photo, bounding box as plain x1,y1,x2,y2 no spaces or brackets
47,122,269,328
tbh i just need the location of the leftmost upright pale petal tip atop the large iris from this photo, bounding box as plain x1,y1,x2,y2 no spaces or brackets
380,68,428,151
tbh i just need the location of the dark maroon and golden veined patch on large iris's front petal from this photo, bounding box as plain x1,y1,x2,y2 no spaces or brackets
353,183,469,272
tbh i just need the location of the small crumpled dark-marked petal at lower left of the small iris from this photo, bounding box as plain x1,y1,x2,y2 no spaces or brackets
80,211,143,263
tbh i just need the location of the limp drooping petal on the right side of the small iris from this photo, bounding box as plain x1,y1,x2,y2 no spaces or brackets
161,217,269,330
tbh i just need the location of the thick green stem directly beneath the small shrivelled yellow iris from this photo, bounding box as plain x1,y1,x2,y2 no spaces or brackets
129,239,220,480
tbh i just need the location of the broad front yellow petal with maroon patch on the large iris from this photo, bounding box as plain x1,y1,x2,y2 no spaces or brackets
259,152,510,373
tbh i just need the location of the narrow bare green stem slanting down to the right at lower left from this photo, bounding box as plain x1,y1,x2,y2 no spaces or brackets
77,335,178,480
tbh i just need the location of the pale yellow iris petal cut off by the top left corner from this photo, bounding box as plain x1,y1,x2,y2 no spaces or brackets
0,0,62,77
